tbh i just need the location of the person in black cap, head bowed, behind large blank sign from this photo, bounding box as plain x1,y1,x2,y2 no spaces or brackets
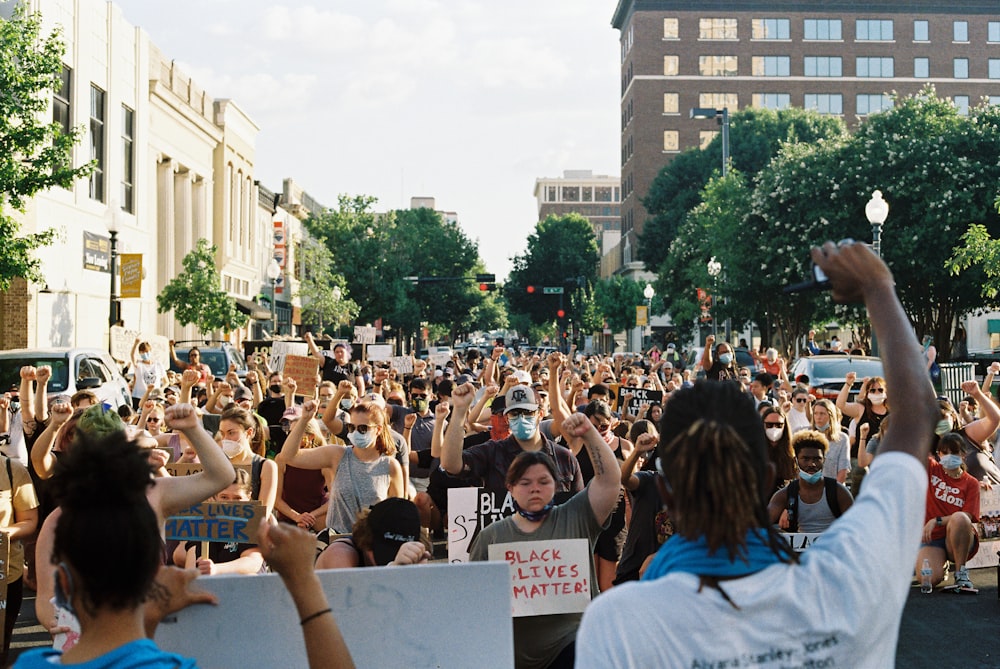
316,497,431,569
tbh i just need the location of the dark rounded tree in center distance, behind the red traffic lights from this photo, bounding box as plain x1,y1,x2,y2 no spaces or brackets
504,214,600,330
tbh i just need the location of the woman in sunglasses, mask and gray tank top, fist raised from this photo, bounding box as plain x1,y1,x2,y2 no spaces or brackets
275,400,406,535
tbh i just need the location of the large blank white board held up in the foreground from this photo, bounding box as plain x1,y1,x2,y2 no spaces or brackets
155,562,514,669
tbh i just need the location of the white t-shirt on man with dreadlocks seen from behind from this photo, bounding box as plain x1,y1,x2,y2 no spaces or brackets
576,452,927,669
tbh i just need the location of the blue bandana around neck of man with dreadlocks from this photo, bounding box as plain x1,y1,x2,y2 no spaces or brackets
642,529,780,581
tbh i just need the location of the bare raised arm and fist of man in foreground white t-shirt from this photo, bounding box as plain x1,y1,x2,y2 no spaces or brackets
812,242,941,462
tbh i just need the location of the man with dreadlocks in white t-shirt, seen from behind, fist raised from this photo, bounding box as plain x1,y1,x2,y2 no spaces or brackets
576,242,940,669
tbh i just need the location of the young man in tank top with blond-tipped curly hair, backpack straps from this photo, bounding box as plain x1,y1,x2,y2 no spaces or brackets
767,430,854,533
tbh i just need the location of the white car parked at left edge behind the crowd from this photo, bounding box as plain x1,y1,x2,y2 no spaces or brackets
0,348,132,409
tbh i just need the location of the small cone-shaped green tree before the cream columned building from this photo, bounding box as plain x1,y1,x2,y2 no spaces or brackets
156,239,249,334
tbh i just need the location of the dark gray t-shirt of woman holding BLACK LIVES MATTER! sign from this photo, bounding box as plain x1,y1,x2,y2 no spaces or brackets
469,486,607,669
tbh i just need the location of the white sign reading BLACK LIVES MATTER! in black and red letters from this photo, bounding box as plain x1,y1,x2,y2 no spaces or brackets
487,539,591,618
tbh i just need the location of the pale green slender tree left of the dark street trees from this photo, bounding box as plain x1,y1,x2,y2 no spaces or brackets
294,237,358,330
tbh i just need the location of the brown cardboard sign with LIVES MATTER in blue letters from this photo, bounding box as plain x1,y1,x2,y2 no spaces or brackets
165,502,264,544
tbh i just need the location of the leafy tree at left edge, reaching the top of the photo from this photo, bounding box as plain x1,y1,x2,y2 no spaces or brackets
0,3,93,290
